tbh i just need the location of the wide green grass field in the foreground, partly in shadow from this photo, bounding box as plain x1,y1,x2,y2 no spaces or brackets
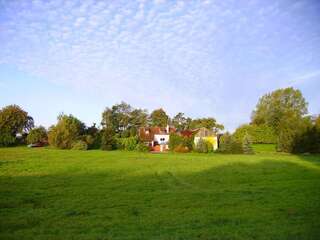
0,147,320,240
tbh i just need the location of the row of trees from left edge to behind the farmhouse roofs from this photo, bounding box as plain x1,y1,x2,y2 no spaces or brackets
0,102,224,151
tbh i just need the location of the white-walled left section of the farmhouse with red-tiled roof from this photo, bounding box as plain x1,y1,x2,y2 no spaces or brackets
138,126,176,152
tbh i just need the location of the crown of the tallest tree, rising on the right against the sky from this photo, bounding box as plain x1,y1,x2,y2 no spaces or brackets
251,88,308,132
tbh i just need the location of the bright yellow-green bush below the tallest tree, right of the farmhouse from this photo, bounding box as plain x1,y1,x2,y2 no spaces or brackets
233,124,277,143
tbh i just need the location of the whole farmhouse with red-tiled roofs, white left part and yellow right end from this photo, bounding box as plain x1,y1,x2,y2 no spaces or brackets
139,126,218,152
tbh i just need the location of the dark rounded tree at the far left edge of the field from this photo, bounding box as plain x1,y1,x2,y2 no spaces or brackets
0,105,34,146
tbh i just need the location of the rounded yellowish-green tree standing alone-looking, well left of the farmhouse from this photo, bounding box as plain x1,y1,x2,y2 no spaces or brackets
48,114,85,149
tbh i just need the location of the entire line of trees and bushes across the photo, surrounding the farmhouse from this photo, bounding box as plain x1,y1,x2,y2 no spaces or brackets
0,88,320,153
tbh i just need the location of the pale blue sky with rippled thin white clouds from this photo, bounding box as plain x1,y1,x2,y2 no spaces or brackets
0,0,320,131
